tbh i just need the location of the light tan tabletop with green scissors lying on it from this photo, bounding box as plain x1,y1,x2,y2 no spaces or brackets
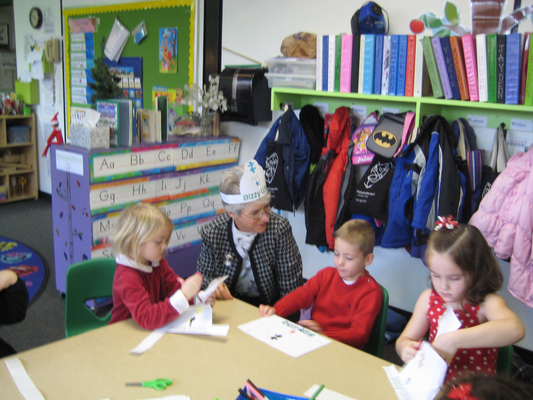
0,299,397,400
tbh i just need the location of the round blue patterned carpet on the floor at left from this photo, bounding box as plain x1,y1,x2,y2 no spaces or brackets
0,236,48,305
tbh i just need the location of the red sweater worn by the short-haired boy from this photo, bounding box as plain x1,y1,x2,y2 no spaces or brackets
274,267,383,349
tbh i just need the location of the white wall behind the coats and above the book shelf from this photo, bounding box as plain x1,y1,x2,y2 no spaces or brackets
222,0,533,350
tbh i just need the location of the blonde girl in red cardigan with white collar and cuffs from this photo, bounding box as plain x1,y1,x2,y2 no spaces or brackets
110,203,215,329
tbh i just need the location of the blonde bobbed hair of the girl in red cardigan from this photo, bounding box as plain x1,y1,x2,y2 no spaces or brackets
110,203,174,266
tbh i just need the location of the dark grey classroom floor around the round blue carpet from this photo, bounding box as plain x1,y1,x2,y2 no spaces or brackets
0,194,401,364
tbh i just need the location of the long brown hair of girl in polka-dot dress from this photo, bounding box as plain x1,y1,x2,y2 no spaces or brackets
426,224,503,305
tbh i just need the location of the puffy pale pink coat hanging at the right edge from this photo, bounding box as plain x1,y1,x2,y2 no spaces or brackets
469,150,533,307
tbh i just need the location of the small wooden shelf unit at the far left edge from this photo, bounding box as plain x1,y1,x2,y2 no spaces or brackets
0,114,39,204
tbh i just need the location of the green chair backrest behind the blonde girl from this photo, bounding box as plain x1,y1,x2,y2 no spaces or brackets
65,258,116,337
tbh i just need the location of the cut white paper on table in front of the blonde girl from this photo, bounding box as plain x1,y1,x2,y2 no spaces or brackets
130,304,229,354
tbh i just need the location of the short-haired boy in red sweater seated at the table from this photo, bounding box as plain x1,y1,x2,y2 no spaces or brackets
259,219,383,349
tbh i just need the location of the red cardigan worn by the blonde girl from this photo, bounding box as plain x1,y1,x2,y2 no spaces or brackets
109,259,181,330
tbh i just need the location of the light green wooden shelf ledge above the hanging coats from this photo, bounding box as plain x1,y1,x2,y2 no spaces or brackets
271,87,533,129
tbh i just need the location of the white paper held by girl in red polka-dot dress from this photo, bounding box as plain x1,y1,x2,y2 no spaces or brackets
383,342,448,400
